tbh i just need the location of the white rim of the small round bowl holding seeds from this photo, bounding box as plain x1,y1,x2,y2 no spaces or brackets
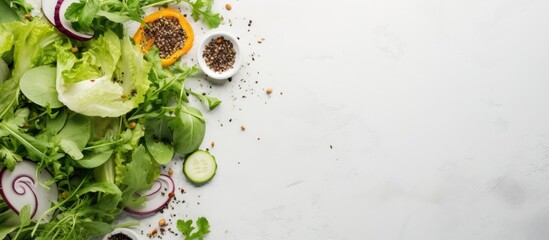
198,31,242,80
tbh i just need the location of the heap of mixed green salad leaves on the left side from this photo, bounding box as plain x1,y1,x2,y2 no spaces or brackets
0,0,221,239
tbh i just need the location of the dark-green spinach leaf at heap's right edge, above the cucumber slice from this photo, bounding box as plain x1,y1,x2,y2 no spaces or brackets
168,106,206,155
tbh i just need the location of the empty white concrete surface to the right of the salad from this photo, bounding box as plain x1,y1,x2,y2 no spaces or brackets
125,0,549,240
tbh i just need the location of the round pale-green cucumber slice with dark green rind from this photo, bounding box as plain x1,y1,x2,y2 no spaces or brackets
183,150,217,184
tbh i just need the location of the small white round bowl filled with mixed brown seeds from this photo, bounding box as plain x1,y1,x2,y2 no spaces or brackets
198,32,241,80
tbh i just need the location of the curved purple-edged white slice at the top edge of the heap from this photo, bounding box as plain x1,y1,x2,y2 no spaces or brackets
53,0,93,41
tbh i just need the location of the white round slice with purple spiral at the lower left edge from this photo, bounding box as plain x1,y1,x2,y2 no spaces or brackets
0,161,57,220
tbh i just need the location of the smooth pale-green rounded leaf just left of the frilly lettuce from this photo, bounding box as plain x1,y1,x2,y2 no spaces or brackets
19,66,64,108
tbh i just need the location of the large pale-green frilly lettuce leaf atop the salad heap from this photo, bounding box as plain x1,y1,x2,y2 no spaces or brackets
56,31,151,117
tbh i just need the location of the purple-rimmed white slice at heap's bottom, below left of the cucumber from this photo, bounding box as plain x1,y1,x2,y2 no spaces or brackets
124,174,175,216
